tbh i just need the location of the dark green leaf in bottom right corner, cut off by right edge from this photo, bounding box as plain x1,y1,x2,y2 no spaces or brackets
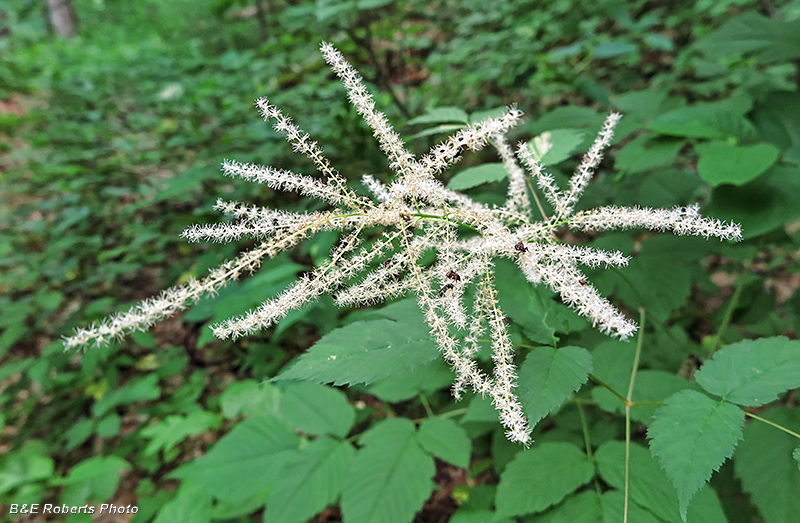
734,407,800,523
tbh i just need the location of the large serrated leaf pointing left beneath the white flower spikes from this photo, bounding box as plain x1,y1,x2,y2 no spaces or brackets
274,311,439,385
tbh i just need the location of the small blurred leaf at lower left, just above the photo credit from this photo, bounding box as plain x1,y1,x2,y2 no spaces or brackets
54,456,131,505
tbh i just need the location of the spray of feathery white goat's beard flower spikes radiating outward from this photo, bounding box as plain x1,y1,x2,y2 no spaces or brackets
65,43,741,444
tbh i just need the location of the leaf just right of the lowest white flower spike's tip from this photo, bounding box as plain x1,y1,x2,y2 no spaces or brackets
519,347,592,427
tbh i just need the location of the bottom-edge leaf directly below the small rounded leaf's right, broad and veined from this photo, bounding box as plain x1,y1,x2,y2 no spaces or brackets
341,418,436,523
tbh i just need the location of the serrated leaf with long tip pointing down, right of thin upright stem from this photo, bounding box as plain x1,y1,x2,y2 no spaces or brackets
647,390,744,521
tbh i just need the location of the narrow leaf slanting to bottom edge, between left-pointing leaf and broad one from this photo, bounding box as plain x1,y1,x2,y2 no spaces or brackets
264,438,355,523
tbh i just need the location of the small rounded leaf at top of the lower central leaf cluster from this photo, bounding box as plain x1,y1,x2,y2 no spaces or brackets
281,382,356,438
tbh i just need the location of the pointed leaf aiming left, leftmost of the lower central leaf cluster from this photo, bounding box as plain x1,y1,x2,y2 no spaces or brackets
169,416,300,502
